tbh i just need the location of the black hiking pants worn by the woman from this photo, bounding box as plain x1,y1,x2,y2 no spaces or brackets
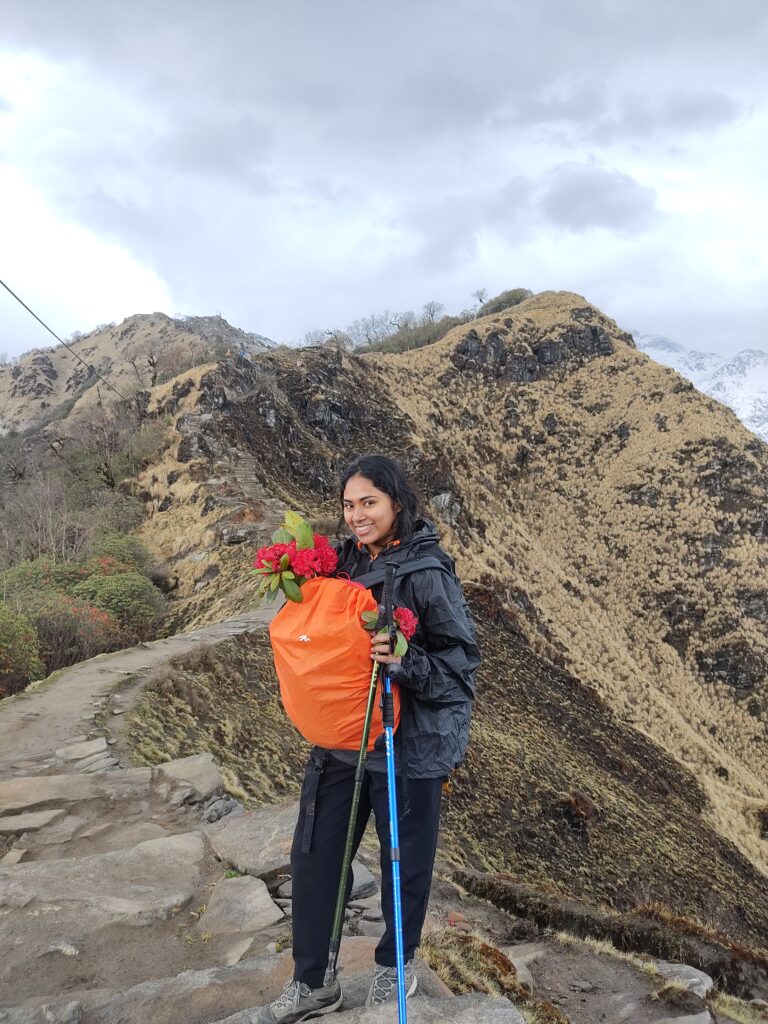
291,752,443,988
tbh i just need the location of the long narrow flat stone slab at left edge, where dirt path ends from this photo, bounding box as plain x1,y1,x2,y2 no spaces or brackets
0,768,152,814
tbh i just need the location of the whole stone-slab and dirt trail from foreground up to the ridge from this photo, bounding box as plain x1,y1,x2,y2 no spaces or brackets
0,613,757,1024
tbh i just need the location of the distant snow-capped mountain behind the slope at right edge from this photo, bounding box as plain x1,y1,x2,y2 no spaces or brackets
633,333,768,441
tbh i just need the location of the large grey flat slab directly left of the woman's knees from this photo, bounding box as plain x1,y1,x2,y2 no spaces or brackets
202,801,299,882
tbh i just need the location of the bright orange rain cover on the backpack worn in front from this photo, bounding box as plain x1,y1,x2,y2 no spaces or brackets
269,577,400,751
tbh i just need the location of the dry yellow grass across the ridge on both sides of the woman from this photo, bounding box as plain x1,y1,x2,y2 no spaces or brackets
121,293,768,871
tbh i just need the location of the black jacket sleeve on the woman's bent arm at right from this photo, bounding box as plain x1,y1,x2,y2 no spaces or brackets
402,569,480,703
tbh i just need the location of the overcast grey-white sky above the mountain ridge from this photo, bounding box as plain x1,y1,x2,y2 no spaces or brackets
0,0,768,354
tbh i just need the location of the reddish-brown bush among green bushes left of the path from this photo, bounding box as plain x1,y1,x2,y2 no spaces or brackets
18,591,124,673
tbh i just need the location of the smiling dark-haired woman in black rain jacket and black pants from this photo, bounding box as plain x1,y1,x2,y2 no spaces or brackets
258,456,479,1024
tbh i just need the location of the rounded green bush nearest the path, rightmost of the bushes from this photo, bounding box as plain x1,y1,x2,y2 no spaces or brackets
74,572,166,642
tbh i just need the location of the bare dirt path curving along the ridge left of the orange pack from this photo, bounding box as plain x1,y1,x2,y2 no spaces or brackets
0,608,274,777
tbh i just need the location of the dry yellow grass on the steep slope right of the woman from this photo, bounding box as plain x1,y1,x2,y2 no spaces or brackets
371,293,768,870
